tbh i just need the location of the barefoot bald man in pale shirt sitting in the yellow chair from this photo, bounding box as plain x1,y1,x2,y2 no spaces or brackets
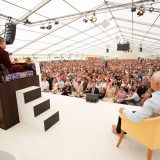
112,71,160,134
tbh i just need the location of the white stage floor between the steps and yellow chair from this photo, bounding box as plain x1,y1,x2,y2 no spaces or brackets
0,94,160,160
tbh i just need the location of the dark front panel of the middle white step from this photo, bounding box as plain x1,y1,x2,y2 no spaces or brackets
34,99,50,117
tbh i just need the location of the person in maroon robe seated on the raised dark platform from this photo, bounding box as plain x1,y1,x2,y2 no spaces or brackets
0,37,32,73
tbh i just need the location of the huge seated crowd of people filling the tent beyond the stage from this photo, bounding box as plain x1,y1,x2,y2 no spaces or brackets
40,59,160,105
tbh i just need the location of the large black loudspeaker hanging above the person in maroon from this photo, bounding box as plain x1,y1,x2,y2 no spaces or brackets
5,23,16,44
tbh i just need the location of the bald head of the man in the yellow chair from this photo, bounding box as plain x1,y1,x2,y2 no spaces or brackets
151,71,160,91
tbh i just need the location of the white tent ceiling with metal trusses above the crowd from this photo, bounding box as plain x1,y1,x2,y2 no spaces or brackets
0,0,160,57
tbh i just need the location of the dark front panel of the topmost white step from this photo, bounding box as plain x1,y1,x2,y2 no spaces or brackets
24,88,41,103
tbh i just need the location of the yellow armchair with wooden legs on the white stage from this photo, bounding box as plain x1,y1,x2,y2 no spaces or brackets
117,114,160,160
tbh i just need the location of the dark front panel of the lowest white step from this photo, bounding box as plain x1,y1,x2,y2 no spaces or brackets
44,111,59,131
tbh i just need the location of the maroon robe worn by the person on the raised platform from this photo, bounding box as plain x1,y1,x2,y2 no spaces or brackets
0,47,25,73
